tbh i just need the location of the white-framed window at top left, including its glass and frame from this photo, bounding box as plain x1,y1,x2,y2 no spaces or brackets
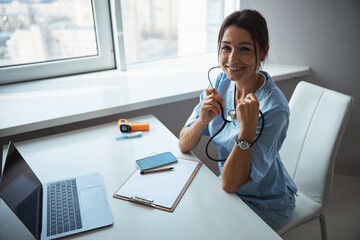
0,0,115,84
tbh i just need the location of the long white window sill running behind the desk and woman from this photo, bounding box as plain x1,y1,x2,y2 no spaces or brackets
0,54,309,137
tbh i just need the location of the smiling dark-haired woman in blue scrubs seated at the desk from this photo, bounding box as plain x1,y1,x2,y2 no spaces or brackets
179,10,297,230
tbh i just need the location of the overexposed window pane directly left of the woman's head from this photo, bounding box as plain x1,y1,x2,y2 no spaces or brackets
121,0,233,64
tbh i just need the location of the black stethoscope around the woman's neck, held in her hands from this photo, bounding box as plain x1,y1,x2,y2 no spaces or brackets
205,66,266,162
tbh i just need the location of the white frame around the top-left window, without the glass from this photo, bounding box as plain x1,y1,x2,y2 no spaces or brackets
0,0,116,85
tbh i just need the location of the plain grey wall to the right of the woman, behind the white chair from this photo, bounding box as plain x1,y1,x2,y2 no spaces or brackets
241,0,360,176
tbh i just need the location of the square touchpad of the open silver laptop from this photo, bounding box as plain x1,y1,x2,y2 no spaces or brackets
80,186,106,211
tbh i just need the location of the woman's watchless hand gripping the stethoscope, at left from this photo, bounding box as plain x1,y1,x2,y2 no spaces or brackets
199,88,225,124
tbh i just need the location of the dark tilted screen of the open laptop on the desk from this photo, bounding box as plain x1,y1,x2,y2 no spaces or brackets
0,142,42,238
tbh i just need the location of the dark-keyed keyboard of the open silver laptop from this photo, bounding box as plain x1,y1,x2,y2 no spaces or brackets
47,179,82,236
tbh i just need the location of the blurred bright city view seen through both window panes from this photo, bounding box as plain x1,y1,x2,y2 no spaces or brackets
0,0,224,67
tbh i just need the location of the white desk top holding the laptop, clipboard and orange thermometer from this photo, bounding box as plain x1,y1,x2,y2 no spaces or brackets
0,115,281,240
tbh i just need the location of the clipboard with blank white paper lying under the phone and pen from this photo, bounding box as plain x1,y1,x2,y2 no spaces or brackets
113,154,202,212
